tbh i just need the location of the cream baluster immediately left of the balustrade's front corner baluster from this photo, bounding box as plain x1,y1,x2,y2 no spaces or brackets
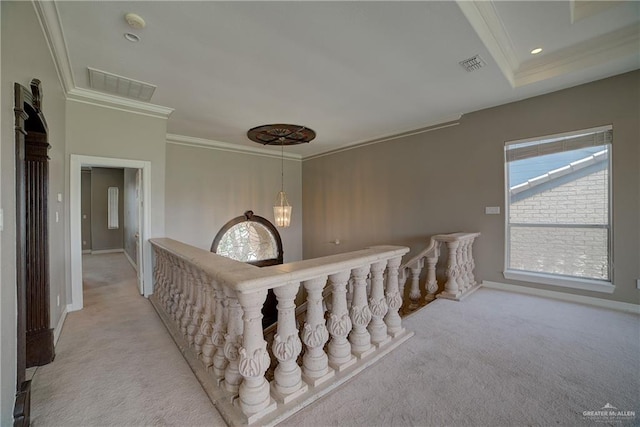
222,286,243,394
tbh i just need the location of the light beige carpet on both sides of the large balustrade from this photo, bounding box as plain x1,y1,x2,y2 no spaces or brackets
32,254,640,427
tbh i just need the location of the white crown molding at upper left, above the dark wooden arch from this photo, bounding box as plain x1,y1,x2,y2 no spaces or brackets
32,0,76,92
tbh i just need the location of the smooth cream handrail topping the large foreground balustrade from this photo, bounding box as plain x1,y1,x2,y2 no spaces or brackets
149,238,409,293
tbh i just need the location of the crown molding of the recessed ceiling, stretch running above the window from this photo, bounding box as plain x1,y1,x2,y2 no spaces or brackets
514,24,640,87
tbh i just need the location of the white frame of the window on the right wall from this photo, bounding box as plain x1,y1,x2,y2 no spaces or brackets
503,125,615,294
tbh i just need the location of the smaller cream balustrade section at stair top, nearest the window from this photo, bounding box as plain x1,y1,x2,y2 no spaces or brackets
400,233,480,311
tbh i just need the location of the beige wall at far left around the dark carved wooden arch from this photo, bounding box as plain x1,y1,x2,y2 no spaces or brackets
0,1,66,426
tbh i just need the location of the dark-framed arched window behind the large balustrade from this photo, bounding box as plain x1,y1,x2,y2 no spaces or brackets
211,211,283,328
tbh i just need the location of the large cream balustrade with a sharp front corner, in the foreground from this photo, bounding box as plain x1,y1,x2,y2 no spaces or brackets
150,239,410,425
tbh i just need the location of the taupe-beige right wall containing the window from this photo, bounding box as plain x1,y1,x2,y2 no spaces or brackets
302,71,640,304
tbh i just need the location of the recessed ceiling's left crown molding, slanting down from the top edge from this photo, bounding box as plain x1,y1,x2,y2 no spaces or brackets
456,0,520,88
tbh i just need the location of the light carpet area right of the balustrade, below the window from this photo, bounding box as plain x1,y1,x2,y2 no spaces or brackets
281,289,640,427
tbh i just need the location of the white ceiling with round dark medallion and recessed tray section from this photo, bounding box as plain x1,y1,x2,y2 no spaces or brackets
42,1,640,158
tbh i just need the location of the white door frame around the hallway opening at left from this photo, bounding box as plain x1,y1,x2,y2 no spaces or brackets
68,154,153,311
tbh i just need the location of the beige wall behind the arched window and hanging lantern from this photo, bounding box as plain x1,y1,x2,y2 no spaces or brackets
166,143,302,262
